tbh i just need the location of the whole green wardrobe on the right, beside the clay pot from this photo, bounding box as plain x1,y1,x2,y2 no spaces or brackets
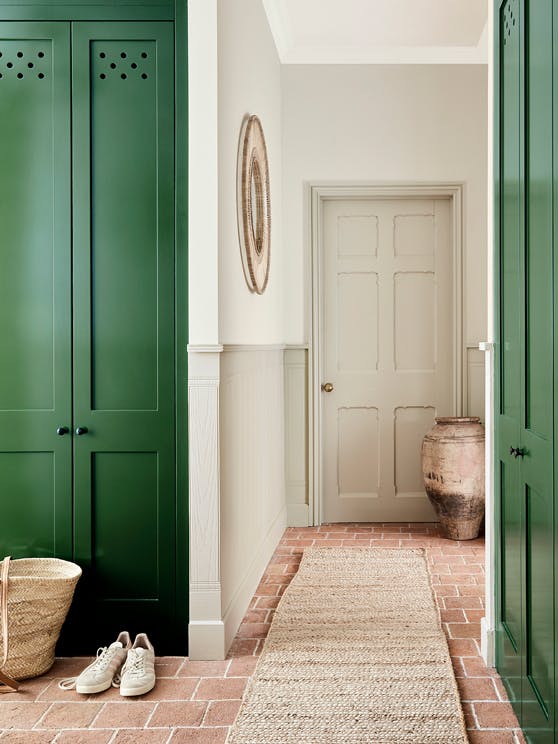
495,0,558,744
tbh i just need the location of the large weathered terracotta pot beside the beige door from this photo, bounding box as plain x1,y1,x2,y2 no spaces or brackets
422,417,484,540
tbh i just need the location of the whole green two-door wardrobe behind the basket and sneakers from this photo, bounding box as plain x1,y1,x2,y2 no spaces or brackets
0,0,188,653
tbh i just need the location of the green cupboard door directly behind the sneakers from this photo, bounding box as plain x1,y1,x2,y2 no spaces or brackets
72,22,177,653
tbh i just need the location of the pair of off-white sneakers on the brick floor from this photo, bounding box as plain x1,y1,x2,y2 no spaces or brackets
59,630,155,697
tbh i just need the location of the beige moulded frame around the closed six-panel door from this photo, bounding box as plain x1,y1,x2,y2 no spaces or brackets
306,181,467,525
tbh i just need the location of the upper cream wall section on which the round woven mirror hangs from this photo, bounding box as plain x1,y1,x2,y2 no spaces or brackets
218,0,285,344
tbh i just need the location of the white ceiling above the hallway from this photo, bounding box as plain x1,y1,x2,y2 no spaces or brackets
262,0,490,64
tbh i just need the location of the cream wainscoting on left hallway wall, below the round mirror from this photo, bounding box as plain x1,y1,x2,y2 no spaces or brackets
220,346,287,649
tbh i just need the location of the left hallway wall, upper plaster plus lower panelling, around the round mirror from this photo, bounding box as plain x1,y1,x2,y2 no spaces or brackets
217,0,286,647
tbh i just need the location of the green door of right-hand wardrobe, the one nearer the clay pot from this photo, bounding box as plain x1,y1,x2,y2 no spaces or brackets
495,0,525,716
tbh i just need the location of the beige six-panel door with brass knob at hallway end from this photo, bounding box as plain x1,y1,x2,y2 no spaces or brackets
321,198,454,522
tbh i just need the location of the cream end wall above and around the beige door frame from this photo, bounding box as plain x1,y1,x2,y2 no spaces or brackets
282,65,487,354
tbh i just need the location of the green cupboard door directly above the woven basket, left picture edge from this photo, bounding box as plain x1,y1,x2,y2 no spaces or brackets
0,23,72,558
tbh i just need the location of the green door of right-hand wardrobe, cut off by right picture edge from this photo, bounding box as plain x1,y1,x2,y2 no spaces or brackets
518,0,554,744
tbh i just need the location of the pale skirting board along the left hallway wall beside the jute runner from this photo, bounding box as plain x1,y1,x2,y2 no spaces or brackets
223,507,287,658
